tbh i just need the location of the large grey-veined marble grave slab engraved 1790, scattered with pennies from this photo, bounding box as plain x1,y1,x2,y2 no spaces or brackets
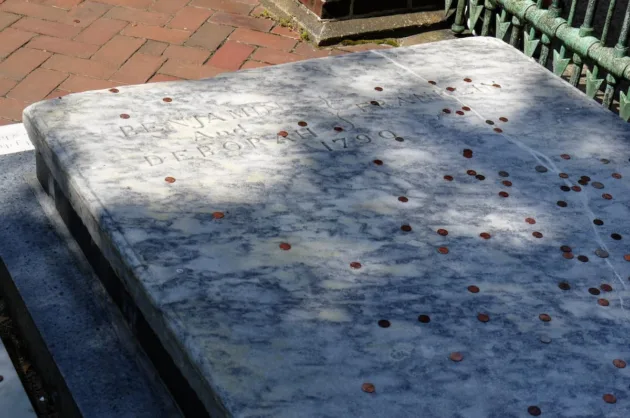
24,38,630,418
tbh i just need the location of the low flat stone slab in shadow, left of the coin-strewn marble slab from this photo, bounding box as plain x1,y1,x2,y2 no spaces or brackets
0,124,181,418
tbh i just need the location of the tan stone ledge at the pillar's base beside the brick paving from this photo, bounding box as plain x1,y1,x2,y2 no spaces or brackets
261,0,452,46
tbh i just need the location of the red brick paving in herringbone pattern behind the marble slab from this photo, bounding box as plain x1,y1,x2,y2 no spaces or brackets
0,0,390,125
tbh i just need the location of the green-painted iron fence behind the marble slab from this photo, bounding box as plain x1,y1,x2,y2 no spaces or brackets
446,0,630,121
